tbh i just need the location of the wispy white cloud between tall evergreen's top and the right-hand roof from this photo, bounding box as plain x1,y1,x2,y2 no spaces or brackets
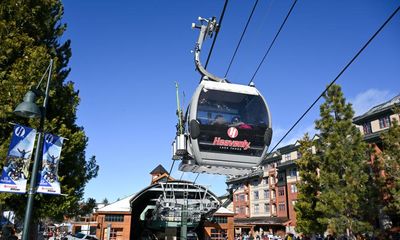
349,89,395,116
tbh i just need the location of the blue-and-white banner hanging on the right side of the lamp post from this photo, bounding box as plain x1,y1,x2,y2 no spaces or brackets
36,133,64,194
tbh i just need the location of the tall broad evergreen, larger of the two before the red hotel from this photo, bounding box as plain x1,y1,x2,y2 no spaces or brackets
316,85,371,238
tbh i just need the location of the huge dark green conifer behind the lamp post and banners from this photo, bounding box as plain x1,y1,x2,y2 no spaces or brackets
0,0,98,220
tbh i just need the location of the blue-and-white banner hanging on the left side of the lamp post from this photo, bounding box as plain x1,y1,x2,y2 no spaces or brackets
0,125,36,193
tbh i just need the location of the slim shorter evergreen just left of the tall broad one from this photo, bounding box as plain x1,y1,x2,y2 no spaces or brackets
294,134,327,235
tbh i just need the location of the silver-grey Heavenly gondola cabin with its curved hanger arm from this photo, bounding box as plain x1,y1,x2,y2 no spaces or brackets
172,17,272,176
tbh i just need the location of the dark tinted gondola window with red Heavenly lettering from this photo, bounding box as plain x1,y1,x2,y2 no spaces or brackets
196,89,269,157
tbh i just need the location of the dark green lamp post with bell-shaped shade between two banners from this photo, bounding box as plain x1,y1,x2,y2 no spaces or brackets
14,60,53,240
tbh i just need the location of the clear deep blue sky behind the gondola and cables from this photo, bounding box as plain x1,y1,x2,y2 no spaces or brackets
63,0,400,201
